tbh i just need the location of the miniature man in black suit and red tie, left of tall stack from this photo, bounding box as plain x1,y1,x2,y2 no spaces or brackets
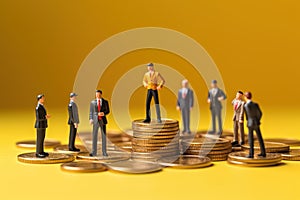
89,90,109,156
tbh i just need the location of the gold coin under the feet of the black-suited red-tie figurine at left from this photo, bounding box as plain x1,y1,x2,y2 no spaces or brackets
76,152,130,164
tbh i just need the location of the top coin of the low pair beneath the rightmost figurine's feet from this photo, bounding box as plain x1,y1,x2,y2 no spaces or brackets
228,152,282,163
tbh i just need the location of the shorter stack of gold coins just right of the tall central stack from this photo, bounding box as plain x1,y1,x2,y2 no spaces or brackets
181,137,232,161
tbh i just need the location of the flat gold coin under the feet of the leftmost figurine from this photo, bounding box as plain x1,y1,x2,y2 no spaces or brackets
18,152,75,164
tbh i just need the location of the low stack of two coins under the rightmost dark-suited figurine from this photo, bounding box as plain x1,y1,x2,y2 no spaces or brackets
228,152,282,167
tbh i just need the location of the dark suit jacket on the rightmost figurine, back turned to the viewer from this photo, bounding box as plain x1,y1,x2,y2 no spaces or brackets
245,101,262,128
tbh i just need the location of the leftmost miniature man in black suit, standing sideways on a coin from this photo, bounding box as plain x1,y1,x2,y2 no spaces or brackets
34,94,50,158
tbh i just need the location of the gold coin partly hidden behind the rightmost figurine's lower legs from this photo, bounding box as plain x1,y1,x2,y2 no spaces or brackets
242,141,290,153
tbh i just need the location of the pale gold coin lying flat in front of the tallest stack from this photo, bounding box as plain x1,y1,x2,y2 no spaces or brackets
107,159,162,174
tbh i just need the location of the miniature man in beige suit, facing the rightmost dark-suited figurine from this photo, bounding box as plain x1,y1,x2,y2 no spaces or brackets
232,91,245,147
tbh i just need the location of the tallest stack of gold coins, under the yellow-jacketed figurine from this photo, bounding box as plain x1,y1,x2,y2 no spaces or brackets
132,119,179,159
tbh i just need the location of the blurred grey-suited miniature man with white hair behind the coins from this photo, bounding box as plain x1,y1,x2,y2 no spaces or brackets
176,80,194,134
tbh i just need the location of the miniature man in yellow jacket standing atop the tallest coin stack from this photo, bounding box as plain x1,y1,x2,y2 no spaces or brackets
143,63,165,123
